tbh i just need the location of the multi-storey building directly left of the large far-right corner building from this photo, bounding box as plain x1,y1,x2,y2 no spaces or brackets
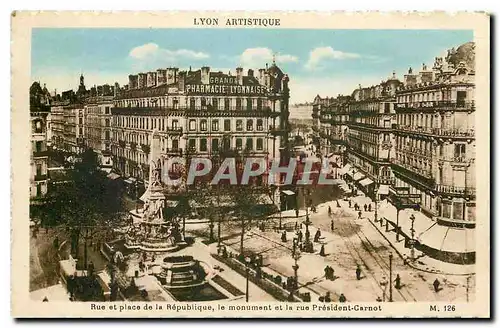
346,73,401,196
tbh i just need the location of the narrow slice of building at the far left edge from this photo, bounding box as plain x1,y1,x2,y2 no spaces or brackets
30,82,50,204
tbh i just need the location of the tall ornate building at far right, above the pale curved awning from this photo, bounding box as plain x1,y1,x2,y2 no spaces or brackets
393,43,476,225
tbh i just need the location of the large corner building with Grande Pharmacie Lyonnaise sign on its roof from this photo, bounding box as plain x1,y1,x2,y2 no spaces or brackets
111,63,289,183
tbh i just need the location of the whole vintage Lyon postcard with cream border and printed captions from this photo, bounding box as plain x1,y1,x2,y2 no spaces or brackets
12,12,490,317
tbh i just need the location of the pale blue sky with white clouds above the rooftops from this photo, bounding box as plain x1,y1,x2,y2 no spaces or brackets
31,28,473,104
